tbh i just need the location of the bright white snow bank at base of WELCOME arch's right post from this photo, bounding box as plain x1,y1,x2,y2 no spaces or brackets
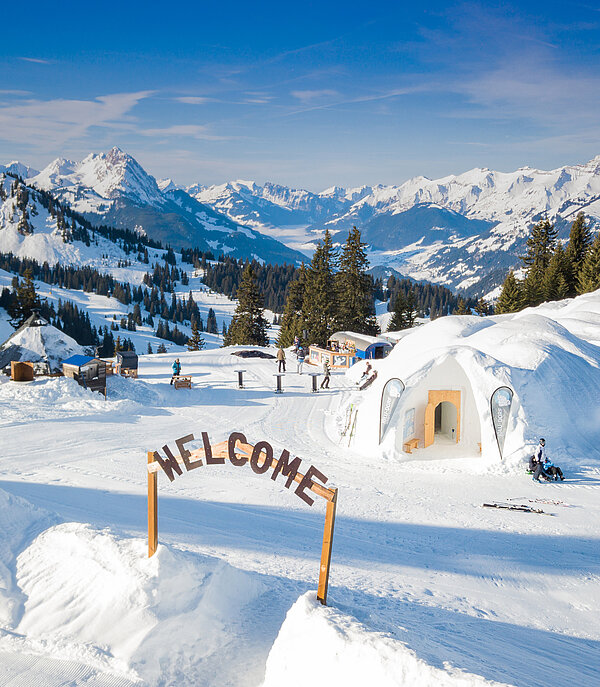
263,592,516,687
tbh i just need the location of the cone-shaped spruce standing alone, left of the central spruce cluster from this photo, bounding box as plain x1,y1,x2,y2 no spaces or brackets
223,264,269,346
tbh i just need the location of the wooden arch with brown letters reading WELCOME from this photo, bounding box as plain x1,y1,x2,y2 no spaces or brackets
148,432,338,606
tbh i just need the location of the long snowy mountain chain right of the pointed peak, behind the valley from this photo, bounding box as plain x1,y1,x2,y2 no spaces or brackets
188,156,600,291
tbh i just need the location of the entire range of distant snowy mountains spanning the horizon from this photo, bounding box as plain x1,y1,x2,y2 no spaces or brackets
0,148,600,293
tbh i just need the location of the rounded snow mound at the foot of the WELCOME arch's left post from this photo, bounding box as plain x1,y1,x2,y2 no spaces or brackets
15,523,263,684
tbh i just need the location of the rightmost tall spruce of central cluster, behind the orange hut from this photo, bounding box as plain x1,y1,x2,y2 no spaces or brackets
334,227,379,334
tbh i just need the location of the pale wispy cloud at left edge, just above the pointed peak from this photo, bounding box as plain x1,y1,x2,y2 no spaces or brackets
0,91,153,149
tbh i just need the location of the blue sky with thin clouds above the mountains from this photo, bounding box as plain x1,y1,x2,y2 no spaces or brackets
0,0,600,190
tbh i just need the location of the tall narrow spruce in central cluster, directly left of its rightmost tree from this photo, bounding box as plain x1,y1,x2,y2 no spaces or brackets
300,230,336,346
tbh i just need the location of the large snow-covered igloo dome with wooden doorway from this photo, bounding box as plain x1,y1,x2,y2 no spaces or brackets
340,291,600,470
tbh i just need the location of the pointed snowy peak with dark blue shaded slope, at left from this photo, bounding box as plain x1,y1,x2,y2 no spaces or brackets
22,148,303,263
